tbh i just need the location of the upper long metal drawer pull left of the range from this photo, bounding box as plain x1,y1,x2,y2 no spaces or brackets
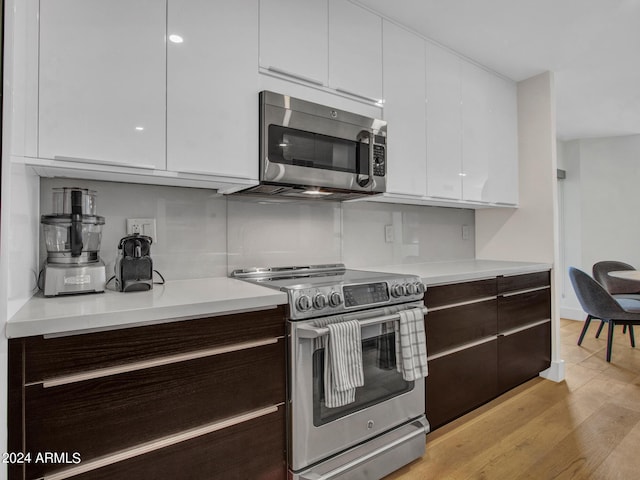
31,338,278,388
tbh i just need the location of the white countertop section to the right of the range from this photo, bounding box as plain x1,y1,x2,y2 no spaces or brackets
366,259,551,286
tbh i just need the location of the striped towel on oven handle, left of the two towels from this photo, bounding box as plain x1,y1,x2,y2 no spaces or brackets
316,320,364,408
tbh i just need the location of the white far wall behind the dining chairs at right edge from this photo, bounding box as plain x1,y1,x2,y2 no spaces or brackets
559,135,640,319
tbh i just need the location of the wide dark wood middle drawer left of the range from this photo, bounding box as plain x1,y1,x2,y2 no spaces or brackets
25,338,286,478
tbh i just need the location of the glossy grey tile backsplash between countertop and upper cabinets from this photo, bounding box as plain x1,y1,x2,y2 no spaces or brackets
40,178,475,280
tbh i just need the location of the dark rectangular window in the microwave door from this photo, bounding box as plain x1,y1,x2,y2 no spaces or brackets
269,125,369,174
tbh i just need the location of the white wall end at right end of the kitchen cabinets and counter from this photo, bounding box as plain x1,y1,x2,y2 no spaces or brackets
476,72,564,381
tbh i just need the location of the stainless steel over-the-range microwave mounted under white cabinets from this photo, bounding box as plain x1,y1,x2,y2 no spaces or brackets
241,91,387,200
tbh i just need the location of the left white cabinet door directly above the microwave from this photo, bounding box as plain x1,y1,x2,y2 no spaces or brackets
258,0,328,86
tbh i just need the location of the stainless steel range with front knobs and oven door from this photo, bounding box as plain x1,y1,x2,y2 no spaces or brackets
232,264,429,480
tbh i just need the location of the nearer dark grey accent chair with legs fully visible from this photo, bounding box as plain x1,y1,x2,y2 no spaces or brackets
569,267,640,362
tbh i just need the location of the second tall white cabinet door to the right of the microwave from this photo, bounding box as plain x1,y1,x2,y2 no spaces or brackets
426,42,464,200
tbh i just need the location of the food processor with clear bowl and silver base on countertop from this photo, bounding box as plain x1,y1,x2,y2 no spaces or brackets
40,187,106,297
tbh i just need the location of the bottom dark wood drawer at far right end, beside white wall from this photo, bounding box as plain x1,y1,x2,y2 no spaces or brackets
498,322,551,393
